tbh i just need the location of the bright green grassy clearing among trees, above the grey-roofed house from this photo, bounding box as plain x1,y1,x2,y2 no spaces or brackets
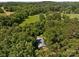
19,15,39,27
